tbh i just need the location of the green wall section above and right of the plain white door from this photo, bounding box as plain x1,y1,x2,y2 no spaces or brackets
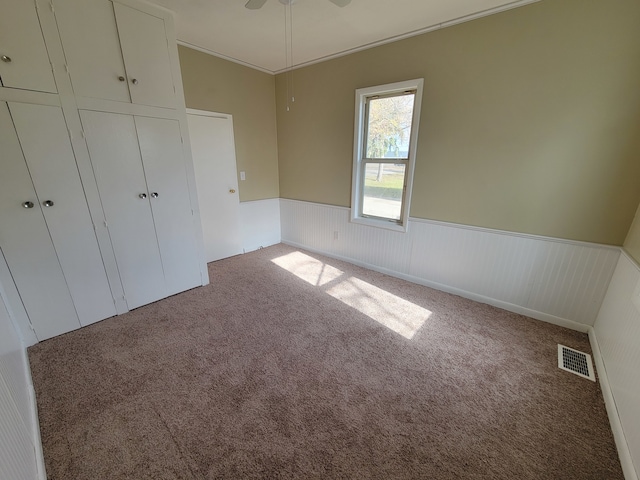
178,46,279,202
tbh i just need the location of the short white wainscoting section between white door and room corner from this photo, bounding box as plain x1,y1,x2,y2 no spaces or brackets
240,198,280,253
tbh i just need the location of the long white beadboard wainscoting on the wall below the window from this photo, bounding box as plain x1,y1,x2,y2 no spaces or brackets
280,199,620,332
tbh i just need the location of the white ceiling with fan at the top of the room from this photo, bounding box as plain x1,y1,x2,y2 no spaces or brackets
150,0,537,73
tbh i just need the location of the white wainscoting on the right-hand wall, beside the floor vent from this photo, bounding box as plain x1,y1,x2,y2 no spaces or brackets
590,252,640,480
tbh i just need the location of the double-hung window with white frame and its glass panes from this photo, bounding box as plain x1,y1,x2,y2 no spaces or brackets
351,79,423,231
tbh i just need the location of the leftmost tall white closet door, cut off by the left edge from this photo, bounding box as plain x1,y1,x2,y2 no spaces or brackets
0,102,80,340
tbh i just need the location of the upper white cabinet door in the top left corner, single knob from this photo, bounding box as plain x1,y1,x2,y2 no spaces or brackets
0,0,57,93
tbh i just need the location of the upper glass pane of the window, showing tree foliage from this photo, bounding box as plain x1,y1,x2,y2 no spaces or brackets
365,93,415,158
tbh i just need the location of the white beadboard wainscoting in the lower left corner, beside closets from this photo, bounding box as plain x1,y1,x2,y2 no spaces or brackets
0,288,46,480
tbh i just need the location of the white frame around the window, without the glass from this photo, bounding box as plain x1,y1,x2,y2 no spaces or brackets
351,78,424,232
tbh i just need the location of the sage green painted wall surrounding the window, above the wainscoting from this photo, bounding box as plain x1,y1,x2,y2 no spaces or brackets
276,0,640,245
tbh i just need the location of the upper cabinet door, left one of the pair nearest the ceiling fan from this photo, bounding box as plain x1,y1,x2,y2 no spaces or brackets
55,0,131,102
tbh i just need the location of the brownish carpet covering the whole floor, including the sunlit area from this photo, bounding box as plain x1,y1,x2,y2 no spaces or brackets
29,245,623,480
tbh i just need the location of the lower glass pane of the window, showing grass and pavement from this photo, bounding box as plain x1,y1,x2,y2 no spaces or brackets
362,163,406,220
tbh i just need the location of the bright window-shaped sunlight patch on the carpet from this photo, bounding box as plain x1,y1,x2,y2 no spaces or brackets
272,252,431,339
